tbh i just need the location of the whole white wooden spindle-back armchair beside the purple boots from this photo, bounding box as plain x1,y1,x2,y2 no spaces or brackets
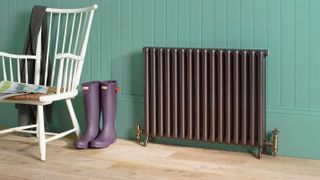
0,5,98,161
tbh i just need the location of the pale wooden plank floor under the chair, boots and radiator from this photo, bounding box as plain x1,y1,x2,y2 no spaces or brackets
0,135,320,180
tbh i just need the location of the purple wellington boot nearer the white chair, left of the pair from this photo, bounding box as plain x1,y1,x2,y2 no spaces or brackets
74,81,100,149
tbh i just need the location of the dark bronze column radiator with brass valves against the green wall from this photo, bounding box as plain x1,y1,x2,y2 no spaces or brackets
136,47,277,158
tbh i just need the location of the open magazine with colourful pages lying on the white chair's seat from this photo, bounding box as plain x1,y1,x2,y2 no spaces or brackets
0,81,48,100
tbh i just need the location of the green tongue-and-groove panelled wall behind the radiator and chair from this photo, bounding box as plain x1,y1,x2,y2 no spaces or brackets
0,0,320,158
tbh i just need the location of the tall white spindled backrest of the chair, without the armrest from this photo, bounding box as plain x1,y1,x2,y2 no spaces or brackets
43,5,98,93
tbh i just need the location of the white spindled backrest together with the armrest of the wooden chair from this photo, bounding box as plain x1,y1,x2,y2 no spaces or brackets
0,5,98,93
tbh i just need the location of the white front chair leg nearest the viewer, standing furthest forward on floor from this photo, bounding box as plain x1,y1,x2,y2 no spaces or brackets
37,105,46,161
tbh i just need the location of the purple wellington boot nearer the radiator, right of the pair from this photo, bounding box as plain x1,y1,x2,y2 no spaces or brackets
90,81,119,148
